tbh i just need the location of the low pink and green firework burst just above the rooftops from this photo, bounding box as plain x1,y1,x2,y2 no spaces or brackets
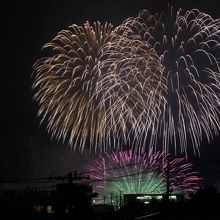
86,150,201,198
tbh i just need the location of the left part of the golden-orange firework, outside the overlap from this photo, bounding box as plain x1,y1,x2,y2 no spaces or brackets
33,22,117,151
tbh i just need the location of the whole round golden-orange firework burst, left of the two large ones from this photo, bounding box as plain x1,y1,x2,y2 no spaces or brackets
33,22,164,151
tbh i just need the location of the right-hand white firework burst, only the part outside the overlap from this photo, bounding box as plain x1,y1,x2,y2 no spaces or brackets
116,7,220,155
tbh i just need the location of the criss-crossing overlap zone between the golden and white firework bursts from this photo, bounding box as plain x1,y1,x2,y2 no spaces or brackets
94,36,165,150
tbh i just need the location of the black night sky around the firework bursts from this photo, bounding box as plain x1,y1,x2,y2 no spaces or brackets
0,0,220,189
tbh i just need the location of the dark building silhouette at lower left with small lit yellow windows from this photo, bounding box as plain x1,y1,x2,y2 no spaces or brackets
0,172,97,217
